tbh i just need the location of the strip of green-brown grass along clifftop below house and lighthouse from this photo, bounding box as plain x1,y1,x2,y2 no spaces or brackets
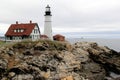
0,40,67,50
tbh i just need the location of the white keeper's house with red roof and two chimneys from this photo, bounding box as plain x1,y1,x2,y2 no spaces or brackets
5,21,41,41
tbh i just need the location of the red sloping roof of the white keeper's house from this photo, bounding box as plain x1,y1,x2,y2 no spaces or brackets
5,23,39,36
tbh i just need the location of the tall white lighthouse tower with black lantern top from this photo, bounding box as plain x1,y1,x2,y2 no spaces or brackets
44,5,53,40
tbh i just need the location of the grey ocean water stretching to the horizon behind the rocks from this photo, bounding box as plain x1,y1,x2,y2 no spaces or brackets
67,38,120,52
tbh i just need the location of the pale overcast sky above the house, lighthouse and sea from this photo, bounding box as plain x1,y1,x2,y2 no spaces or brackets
0,0,120,36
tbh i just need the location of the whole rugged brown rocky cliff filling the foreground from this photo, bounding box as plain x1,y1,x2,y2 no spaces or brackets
0,40,120,80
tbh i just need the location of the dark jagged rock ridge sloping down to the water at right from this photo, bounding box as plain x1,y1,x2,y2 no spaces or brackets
75,42,120,75
